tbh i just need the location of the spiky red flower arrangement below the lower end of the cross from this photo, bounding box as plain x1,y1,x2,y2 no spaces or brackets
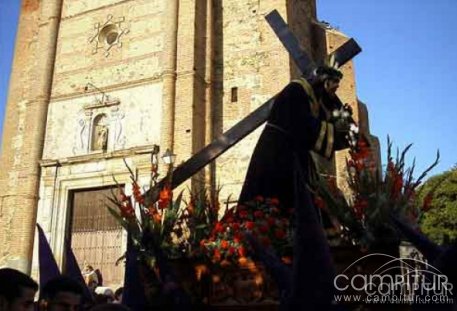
108,155,228,262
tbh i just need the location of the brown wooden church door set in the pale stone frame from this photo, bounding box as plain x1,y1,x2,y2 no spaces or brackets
71,188,124,291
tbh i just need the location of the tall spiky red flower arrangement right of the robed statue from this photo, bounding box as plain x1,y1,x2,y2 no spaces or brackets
316,137,439,246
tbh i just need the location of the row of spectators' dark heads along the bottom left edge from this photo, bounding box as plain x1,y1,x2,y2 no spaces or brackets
0,268,130,311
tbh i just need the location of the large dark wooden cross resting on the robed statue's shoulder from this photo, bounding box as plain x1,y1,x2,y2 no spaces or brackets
151,10,361,189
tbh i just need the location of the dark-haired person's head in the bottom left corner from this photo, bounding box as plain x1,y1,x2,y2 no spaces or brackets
0,268,38,311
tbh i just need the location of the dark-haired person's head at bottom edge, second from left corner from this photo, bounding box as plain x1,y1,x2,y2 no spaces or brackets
40,276,83,311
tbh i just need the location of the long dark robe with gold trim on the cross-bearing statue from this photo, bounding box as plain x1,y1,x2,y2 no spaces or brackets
238,79,346,208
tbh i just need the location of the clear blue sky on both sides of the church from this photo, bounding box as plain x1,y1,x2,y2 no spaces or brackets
0,0,457,175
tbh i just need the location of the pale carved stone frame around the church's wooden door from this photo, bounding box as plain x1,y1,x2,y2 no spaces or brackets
32,145,158,275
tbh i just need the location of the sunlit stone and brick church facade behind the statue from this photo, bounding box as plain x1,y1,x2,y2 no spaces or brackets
0,0,378,284
